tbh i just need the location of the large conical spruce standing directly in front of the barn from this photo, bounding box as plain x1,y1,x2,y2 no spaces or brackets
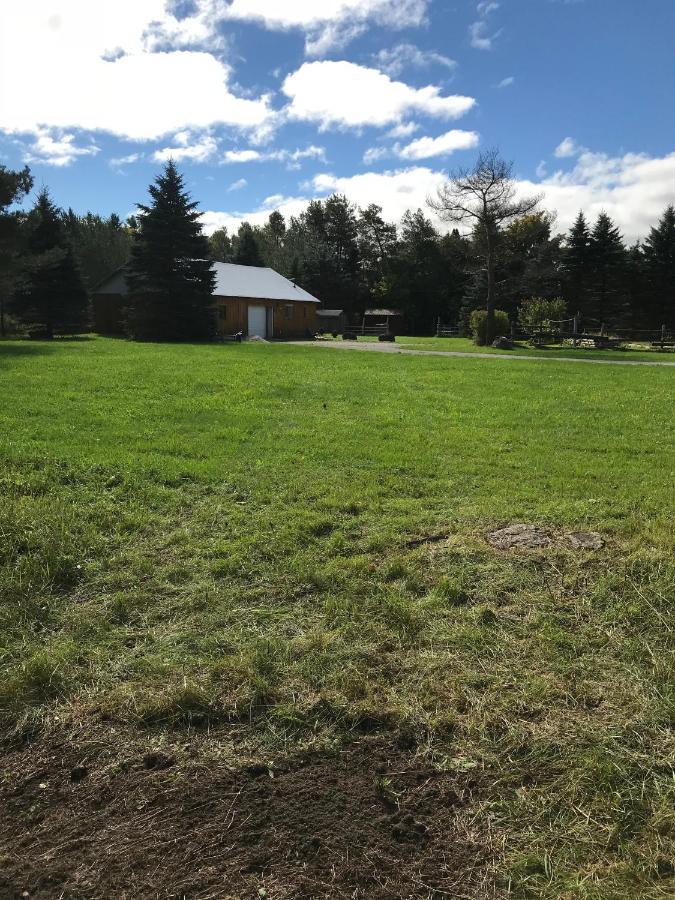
128,161,216,341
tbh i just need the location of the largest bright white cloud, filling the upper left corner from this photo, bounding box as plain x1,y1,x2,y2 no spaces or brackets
0,0,271,140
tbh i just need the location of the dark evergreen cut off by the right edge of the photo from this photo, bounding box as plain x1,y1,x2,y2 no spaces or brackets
643,206,675,328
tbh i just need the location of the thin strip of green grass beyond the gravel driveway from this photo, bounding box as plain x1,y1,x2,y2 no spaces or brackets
325,335,675,365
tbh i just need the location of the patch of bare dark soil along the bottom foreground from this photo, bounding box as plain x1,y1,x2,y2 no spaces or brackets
0,738,492,900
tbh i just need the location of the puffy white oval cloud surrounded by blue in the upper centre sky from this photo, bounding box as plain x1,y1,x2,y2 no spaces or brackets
283,60,476,129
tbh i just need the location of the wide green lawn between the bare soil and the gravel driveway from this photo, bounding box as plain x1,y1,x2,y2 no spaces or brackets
0,339,675,900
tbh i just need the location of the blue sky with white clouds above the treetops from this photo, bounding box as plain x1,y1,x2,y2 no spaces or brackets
0,0,675,240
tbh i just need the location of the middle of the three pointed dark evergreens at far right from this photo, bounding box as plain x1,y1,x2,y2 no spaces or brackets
590,213,628,324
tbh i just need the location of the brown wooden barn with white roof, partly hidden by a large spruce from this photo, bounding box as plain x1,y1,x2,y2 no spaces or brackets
93,263,319,339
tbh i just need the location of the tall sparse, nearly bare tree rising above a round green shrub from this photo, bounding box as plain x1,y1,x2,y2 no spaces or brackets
427,149,541,344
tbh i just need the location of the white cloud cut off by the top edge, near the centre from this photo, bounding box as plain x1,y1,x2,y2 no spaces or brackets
224,0,428,56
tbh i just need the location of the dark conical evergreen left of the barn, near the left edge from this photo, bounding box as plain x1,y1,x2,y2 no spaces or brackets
12,189,89,338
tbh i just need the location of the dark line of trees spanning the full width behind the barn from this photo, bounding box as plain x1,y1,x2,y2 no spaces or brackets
0,151,675,338
